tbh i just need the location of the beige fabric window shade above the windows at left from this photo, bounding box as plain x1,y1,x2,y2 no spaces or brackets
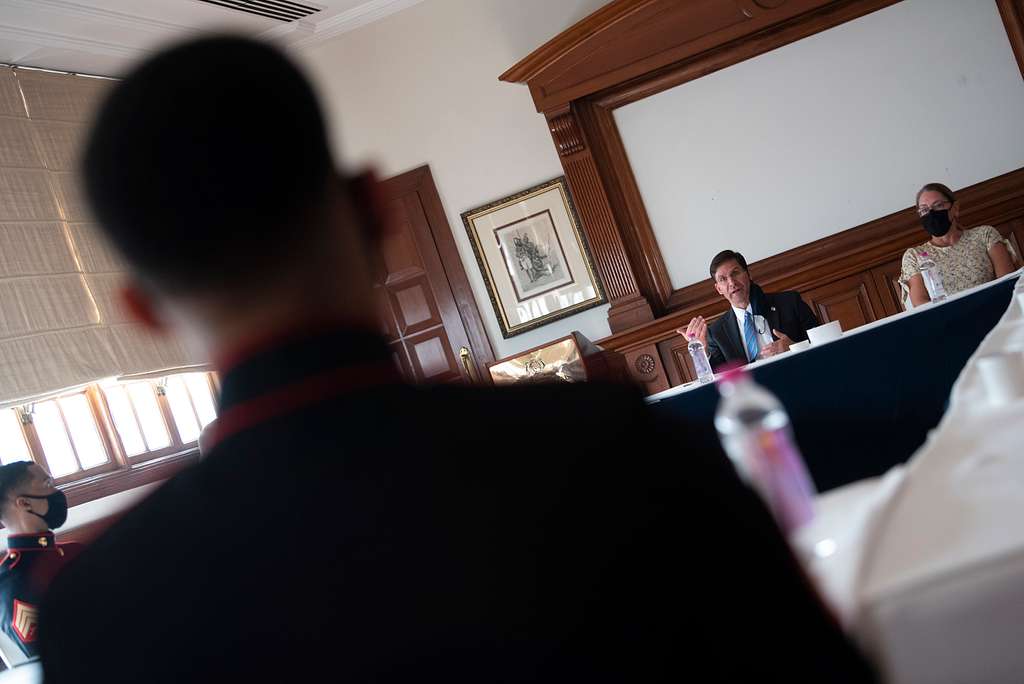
0,68,204,405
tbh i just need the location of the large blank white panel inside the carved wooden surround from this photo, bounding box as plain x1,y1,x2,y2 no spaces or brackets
615,0,1024,288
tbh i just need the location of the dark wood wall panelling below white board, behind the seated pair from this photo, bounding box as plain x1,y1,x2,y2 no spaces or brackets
598,168,1024,352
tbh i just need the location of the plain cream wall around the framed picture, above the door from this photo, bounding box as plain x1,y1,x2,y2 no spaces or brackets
300,0,609,357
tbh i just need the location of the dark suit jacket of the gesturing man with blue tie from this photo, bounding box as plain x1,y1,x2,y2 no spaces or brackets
708,283,818,370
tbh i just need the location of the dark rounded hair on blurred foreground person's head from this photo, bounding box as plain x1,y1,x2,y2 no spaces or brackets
83,37,333,293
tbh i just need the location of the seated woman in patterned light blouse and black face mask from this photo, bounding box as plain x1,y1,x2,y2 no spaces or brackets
900,183,1017,306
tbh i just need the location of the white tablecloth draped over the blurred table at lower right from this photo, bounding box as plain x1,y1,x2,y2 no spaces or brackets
794,270,1024,683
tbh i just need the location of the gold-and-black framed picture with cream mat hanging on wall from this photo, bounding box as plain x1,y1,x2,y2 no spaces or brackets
462,176,606,338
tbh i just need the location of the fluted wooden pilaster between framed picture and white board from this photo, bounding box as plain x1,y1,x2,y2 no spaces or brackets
548,105,654,332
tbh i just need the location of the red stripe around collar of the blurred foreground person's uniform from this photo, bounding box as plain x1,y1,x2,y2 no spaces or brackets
212,360,401,448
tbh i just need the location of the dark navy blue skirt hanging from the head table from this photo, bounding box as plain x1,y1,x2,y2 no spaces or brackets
651,279,1016,491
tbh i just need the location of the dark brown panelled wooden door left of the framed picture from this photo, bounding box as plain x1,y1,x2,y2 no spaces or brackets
375,166,494,383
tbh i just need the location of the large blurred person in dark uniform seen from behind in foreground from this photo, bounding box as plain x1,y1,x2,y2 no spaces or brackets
40,38,872,684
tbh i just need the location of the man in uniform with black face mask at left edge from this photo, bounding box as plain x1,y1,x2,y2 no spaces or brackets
0,461,80,656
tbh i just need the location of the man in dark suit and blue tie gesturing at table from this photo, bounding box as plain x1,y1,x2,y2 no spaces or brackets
676,250,818,370
